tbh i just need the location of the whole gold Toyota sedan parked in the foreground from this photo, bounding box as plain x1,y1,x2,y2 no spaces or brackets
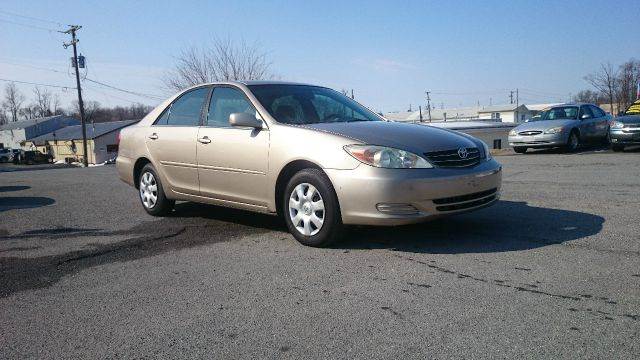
116,81,502,246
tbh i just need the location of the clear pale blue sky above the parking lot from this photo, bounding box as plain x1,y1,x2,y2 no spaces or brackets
0,0,640,112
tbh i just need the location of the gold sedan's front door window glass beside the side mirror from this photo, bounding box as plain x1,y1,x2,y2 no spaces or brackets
207,87,259,127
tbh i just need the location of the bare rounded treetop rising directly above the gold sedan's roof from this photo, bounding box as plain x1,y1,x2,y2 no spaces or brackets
163,38,274,91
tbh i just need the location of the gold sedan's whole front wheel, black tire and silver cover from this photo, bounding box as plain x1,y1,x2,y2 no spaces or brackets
282,169,344,247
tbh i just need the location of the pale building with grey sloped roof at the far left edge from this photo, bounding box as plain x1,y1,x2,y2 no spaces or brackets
0,115,80,149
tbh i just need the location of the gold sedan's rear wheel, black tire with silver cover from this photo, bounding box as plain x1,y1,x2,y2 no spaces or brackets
138,164,175,216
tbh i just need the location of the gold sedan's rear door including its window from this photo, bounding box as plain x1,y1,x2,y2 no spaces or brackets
145,86,211,195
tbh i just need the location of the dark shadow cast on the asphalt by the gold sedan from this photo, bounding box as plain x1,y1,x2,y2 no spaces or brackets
171,200,604,254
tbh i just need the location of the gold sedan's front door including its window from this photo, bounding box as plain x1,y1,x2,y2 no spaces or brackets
197,86,269,206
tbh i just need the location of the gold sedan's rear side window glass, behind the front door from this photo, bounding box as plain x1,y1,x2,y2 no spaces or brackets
156,88,209,126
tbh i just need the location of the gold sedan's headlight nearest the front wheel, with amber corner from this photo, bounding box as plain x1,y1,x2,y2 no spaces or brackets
344,145,433,169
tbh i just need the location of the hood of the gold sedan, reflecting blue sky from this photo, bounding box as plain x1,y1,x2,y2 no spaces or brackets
303,121,482,154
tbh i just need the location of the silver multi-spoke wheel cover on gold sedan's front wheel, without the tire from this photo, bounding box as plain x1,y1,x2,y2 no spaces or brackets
289,183,325,236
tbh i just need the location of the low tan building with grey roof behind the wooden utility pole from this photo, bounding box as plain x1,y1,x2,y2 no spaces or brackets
23,120,139,164
